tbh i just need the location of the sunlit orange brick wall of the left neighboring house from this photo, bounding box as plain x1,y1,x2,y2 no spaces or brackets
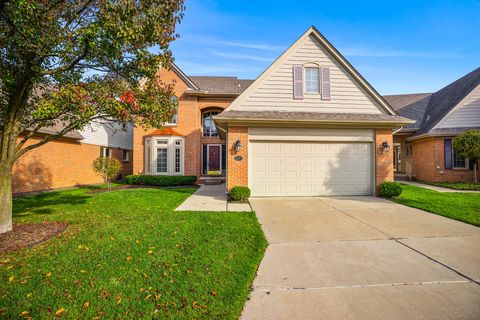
13,137,132,193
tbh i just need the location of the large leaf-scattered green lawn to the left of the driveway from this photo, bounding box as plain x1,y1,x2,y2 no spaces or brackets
0,188,266,319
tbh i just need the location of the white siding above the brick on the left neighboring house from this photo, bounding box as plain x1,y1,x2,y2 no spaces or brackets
79,122,133,150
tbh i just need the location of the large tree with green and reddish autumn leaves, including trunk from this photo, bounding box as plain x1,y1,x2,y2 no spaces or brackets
0,0,184,233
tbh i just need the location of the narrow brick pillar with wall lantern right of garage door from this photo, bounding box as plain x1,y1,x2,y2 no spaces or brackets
374,129,393,192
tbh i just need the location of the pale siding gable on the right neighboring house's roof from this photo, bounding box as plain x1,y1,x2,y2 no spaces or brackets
435,86,480,128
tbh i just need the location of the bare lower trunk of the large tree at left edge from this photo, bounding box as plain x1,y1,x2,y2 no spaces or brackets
0,164,12,233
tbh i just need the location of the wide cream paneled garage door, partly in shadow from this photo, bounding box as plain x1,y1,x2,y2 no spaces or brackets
249,141,372,196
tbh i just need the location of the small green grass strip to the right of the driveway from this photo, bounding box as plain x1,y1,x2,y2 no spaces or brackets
393,184,480,226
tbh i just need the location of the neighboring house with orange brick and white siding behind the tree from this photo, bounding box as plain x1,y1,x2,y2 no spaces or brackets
13,123,133,193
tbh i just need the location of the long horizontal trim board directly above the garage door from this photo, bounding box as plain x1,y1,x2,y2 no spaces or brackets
248,127,374,142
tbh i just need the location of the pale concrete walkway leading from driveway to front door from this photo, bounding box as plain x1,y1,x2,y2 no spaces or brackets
175,183,252,211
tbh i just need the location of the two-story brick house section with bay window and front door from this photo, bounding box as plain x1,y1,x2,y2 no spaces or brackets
129,65,252,182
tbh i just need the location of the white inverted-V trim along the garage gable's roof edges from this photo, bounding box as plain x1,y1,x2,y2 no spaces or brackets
225,26,397,115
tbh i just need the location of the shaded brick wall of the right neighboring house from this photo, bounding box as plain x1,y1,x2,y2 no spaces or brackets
412,138,480,182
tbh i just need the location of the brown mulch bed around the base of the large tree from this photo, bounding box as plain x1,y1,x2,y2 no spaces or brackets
0,222,68,253
